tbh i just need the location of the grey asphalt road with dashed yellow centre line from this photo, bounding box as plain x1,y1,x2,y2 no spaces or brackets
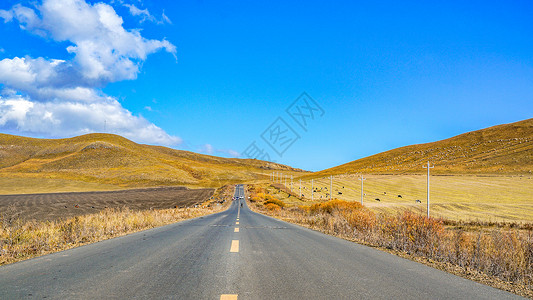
0,186,519,299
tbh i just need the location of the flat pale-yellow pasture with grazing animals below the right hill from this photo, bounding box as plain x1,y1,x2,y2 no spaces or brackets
274,175,533,223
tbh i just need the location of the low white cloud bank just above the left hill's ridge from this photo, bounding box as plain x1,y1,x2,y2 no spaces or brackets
0,95,181,146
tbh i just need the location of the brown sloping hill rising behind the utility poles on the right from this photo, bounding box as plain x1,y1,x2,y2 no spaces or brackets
304,119,533,177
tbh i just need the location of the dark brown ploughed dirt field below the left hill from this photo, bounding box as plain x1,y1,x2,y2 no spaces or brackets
0,187,214,221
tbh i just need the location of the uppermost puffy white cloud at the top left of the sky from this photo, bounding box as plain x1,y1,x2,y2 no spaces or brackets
0,0,176,85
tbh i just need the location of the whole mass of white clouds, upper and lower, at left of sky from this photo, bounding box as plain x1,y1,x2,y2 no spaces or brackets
0,0,181,145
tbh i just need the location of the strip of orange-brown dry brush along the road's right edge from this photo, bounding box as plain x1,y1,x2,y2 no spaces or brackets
248,185,533,297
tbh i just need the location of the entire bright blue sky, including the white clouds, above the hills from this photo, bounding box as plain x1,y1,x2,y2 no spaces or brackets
0,0,533,170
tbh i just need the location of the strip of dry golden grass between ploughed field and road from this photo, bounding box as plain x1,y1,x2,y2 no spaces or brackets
0,186,233,265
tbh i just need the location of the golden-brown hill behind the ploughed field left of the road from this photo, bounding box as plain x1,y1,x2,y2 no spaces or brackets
0,134,302,189
